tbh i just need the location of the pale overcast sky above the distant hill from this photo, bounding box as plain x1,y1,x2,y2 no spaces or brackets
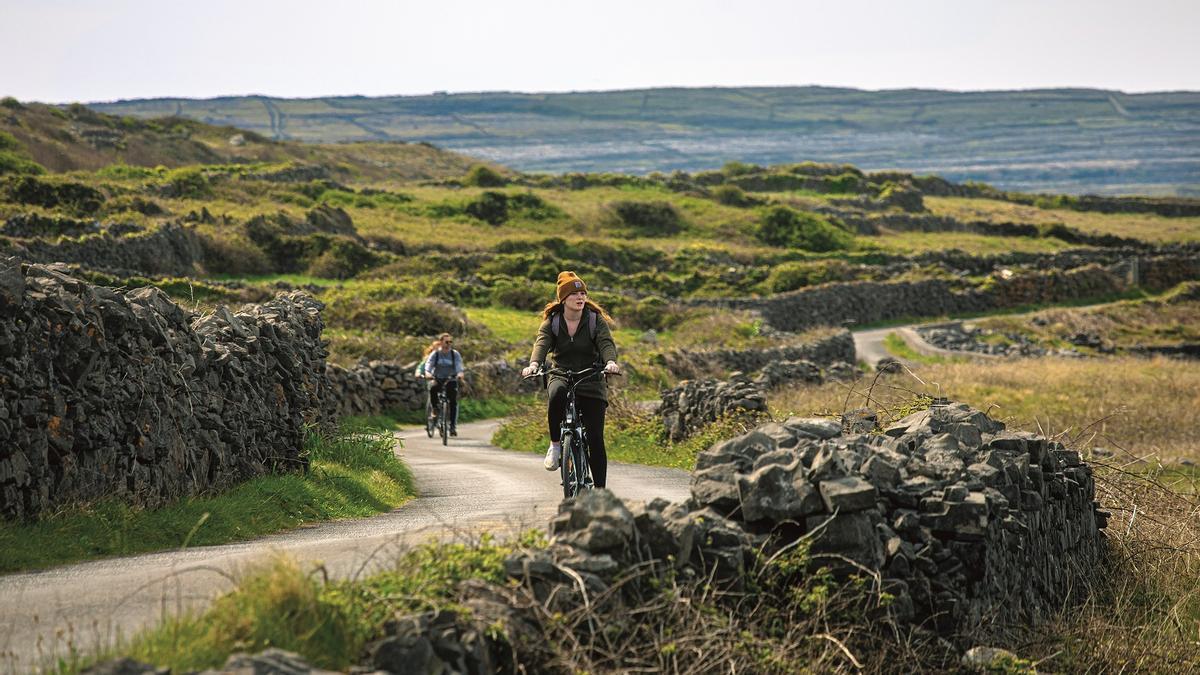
0,0,1200,102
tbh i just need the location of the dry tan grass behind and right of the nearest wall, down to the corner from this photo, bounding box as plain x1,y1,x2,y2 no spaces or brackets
773,358,1200,673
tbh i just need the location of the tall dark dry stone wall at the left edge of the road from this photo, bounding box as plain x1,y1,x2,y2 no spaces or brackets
0,258,325,518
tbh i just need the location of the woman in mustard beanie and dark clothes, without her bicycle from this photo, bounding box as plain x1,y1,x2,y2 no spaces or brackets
521,271,620,488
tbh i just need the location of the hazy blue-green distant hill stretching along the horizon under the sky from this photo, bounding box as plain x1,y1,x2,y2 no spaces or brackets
91,86,1200,195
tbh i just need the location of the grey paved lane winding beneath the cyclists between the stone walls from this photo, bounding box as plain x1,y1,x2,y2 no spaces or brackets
0,422,689,673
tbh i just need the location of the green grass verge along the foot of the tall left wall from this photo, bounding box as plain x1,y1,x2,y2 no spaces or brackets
0,420,414,573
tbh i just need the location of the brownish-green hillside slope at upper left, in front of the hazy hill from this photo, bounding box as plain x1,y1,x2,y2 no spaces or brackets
0,98,487,180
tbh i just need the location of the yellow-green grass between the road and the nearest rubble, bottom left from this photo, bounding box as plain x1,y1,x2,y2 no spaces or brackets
50,531,545,674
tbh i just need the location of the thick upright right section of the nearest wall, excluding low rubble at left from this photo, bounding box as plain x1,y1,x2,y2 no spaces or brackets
692,404,1108,634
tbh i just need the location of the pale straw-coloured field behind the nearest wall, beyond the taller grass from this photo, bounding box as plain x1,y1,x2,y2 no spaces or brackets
772,357,1200,461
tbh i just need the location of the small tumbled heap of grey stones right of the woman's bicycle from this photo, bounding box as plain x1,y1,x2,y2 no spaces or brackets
659,374,767,441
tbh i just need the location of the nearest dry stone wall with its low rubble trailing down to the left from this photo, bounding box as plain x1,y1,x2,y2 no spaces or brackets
326,404,1106,673
